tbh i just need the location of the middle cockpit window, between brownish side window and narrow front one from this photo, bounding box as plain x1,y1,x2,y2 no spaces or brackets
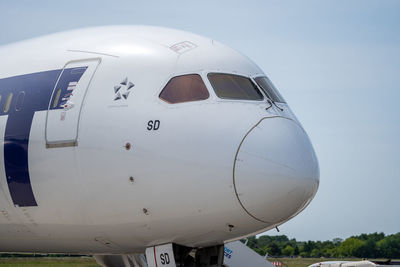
208,73,264,100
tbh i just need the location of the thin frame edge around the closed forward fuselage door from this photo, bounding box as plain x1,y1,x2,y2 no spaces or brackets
44,57,102,148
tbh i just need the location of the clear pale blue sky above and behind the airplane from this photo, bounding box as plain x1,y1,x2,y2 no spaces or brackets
0,0,400,243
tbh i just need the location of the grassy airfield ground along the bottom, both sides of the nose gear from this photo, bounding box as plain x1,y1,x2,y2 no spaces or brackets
0,257,396,267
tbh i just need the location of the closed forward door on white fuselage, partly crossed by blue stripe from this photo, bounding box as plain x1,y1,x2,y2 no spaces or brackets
45,58,101,148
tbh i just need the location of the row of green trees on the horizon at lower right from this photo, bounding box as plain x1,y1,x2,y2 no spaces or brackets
247,232,400,259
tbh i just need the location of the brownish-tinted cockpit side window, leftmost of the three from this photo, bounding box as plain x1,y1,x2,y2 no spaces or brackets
159,74,210,104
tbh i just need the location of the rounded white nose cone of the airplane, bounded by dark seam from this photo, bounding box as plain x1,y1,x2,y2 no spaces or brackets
233,117,319,223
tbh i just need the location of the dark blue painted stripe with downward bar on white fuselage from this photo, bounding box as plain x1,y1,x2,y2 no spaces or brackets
0,68,86,207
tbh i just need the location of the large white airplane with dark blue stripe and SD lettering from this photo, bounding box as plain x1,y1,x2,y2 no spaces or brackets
0,26,319,266
